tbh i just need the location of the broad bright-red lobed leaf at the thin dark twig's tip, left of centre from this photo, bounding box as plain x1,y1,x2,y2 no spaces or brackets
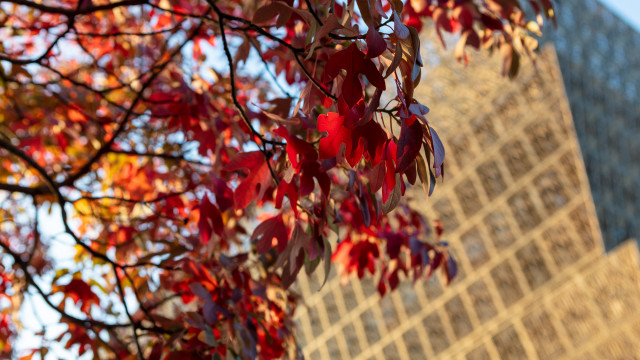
224,151,271,210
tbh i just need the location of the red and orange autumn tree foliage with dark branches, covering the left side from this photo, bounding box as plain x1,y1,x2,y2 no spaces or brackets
0,0,553,359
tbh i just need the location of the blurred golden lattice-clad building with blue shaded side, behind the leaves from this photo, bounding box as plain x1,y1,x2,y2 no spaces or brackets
296,0,640,360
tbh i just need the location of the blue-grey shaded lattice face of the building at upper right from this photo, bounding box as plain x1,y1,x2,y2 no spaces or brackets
546,0,640,250
